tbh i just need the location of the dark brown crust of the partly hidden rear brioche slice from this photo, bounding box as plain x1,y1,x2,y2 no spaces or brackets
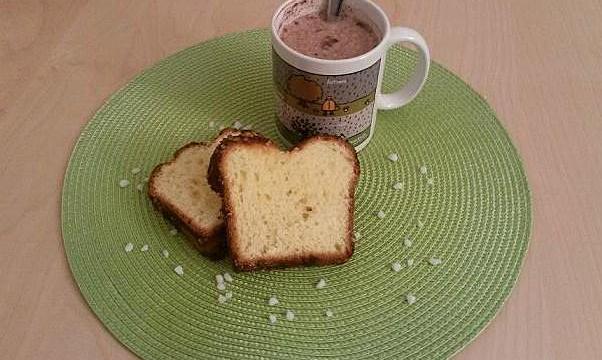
148,128,261,259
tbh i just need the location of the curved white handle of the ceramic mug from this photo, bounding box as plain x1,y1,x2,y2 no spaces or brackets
376,27,431,110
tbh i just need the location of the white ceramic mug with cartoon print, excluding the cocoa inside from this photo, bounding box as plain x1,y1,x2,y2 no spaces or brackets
272,0,430,151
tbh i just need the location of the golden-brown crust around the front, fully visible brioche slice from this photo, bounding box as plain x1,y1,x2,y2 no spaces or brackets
208,135,360,271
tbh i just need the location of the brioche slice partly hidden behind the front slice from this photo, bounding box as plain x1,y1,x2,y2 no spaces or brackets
148,128,260,259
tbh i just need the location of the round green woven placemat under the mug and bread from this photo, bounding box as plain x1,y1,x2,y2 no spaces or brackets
62,30,531,359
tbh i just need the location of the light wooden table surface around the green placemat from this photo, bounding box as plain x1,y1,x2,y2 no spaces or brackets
0,0,602,359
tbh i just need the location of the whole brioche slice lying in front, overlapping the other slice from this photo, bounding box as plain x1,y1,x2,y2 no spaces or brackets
208,135,360,270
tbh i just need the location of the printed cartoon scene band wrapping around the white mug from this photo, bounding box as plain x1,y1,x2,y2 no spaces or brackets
272,49,380,144
